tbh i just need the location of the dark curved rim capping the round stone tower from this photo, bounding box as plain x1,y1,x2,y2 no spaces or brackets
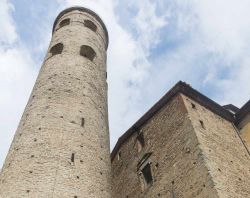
52,6,109,49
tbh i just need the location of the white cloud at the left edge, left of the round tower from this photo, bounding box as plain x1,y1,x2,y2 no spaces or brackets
0,0,36,167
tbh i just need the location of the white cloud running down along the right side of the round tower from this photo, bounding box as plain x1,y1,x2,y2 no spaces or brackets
59,0,166,147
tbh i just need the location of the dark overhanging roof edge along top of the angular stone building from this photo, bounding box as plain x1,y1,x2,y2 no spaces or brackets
111,81,235,161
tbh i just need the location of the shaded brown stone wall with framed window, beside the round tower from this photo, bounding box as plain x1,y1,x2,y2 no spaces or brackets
112,94,219,198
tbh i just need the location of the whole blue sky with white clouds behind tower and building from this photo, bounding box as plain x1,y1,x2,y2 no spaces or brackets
0,0,250,167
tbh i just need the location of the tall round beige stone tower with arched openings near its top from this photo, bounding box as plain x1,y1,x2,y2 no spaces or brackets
0,7,111,198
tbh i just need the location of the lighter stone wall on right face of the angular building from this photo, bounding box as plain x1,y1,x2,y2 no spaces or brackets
183,93,250,198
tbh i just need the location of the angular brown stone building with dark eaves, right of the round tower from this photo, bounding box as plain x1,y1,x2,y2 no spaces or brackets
111,82,250,198
